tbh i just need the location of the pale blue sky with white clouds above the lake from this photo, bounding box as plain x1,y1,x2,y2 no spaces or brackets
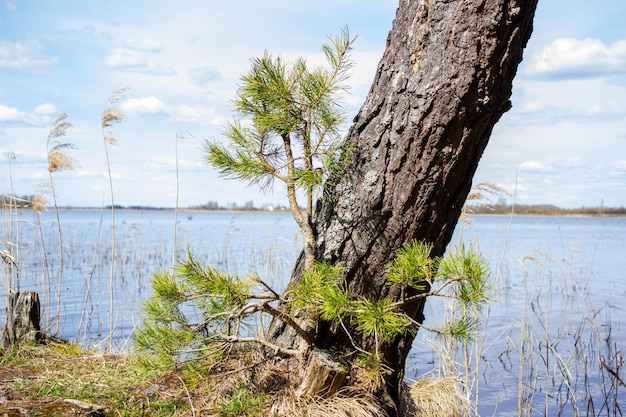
0,0,626,207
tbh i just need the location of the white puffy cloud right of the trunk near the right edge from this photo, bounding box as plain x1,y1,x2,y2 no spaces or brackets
528,38,626,79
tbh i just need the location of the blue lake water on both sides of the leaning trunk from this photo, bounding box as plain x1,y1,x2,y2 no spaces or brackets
0,210,626,416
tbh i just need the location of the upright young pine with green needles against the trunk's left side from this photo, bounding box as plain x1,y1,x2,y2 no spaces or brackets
204,29,356,268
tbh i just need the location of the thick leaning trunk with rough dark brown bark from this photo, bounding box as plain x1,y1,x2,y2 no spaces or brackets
266,0,537,415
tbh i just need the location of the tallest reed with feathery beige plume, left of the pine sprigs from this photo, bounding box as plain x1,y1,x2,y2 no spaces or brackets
101,87,128,350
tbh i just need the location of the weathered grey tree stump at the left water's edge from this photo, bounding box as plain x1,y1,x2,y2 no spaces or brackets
2,292,43,346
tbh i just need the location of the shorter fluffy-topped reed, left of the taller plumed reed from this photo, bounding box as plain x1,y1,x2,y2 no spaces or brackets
47,113,75,335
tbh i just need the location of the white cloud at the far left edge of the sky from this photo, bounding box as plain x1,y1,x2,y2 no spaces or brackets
0,40,58,73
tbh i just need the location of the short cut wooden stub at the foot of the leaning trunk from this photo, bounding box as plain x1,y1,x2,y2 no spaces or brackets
297,349,348,398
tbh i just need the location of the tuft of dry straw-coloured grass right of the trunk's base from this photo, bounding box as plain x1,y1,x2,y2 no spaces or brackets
411,377,469,417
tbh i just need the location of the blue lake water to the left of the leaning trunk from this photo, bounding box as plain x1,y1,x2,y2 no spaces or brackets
0,210,301,347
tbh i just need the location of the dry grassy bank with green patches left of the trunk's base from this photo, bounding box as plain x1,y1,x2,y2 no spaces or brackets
0,342,400,417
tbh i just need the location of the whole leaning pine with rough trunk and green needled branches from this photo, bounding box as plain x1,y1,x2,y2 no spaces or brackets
136,0,537,416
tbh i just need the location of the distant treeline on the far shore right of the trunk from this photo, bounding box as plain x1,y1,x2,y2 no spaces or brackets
470,203,626,216
